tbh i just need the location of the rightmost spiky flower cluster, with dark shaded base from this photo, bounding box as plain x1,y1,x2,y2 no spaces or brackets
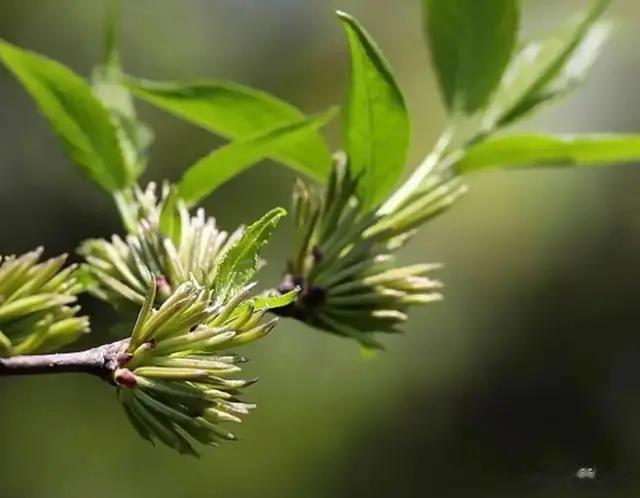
279,155,465,348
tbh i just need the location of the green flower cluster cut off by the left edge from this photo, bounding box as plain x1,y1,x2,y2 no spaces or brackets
0,248,89,356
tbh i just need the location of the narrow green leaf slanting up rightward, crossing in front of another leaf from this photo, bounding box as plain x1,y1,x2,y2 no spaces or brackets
178,109,336,205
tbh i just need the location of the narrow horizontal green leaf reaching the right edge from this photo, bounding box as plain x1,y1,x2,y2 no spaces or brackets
456,134,640,173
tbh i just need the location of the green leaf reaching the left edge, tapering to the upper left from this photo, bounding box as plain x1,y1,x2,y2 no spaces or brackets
0,41,132,192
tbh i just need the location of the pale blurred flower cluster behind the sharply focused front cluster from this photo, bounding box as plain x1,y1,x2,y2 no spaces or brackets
78,184,244,305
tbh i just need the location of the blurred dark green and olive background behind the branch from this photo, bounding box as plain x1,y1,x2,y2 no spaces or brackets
0,0,640,498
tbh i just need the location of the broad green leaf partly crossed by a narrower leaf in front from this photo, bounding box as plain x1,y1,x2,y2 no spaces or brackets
127,79,331,181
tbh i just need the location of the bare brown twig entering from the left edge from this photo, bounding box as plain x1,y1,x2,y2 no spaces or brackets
0,339,129,380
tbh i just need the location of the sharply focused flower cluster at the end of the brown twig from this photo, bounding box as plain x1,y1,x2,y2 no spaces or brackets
113,281,293,456
